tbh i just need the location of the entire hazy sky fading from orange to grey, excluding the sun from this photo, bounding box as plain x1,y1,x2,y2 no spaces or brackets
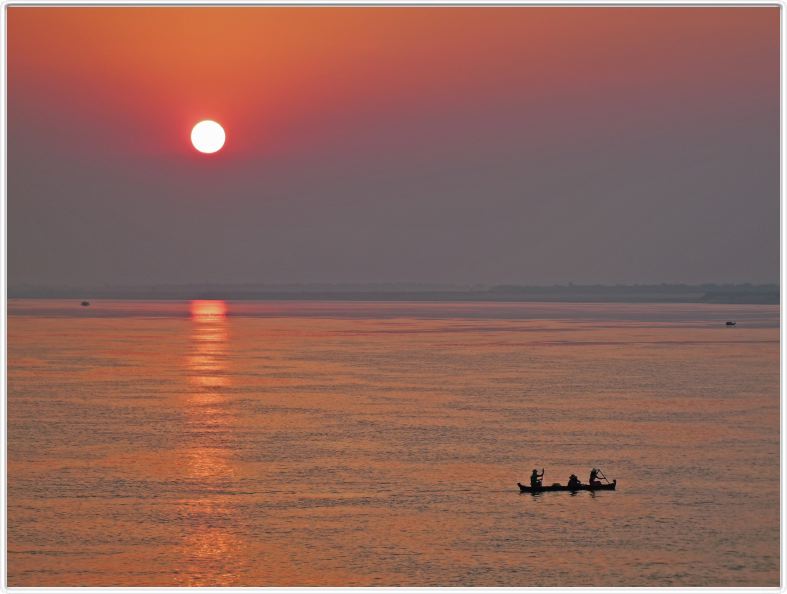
8,7,779,288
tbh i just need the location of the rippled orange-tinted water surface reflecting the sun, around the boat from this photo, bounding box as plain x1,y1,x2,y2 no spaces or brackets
8,300,779,586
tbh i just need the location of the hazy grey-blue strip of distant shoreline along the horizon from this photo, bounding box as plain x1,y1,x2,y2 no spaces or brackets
8,283,779,304
